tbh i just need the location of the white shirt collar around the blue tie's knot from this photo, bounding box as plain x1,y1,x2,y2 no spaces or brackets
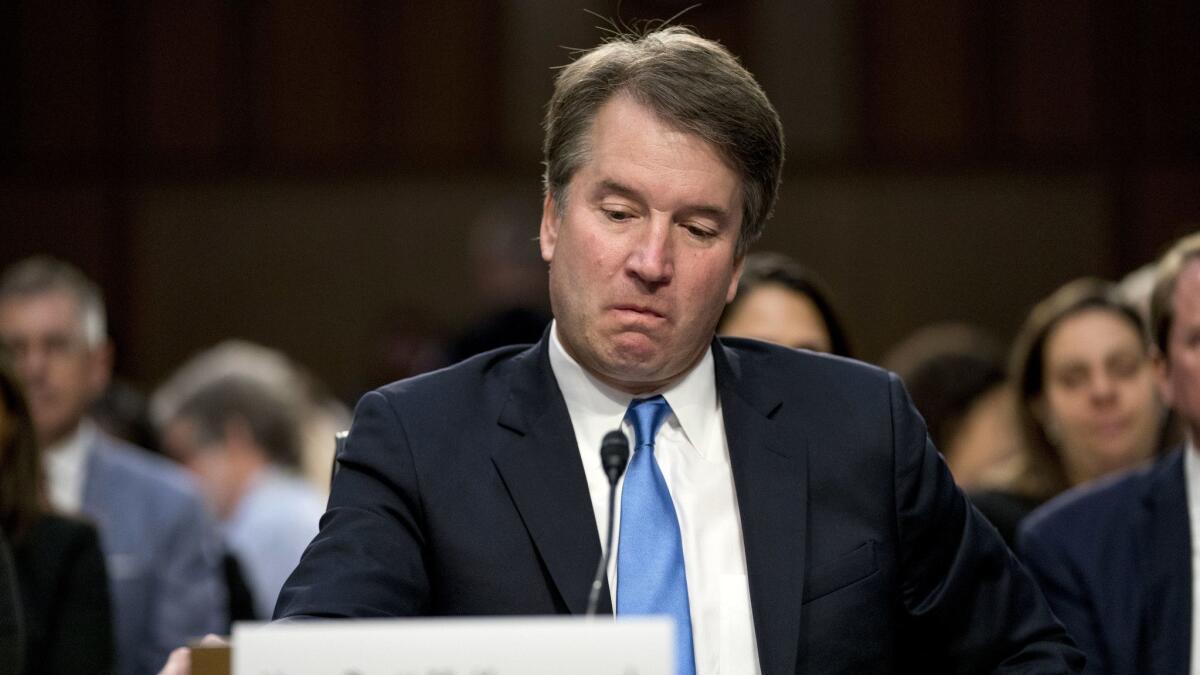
550,319,720,459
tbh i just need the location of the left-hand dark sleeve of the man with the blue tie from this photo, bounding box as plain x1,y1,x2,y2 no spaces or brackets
275,392,430,620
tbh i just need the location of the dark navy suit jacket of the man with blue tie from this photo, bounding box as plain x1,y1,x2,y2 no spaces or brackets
276,338,1081,675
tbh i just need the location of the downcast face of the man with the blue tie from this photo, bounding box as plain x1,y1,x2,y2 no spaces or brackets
540,95,742,393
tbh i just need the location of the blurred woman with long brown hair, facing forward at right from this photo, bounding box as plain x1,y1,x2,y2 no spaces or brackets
973,279,1164,542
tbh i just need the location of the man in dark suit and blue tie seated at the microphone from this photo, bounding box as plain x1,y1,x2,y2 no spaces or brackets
260,29,1081,674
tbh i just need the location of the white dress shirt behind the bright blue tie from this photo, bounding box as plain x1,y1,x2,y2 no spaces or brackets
550,323,760,675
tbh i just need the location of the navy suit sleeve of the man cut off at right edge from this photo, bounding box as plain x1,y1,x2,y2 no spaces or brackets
1016,516,1109,674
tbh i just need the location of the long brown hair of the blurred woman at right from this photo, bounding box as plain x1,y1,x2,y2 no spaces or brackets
1009,279,1148,498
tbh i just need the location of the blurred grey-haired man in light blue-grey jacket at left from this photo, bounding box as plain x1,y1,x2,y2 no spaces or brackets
0,257,227,674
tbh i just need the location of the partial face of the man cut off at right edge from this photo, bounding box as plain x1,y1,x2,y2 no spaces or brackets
1159,259,1200,443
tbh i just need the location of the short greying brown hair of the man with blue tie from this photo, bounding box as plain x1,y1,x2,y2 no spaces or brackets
542,26,784,256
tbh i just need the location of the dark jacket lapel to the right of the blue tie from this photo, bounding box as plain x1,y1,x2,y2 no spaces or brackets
713,342,808,673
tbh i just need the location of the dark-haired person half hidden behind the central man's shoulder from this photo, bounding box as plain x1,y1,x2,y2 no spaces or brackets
716,252,852,357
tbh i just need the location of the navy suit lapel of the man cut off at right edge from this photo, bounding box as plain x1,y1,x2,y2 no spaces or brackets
1138,450,1193,673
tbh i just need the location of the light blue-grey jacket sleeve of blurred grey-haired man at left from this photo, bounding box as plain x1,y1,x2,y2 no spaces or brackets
138,494,229,673
